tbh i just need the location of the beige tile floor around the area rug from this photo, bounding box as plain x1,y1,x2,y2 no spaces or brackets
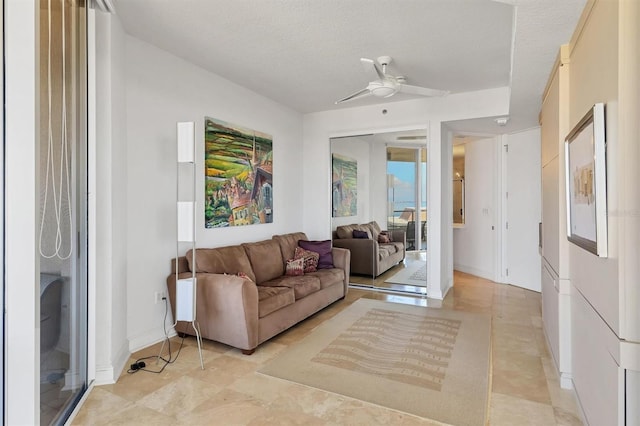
72,272,582,426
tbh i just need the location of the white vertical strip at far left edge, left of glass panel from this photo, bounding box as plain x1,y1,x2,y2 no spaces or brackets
4,0,40,425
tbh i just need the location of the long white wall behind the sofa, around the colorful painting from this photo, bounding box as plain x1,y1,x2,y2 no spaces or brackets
125,37,304,350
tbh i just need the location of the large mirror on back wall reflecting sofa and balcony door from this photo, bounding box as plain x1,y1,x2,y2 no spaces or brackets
330,131,427,294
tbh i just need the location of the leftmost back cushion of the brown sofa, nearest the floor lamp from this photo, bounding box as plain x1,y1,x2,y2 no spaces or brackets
186,246,256,281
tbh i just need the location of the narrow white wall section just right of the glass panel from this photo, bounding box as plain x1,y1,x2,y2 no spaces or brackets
89,13,129,384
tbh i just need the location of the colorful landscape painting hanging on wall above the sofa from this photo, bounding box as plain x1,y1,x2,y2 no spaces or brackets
204,117,273,228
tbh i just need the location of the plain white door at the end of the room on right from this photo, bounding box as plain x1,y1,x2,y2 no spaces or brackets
502,129,541,291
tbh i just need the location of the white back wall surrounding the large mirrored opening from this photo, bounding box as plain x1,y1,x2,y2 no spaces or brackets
302,88,509,298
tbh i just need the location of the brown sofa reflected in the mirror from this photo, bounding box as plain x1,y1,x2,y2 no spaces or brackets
333,221,407,277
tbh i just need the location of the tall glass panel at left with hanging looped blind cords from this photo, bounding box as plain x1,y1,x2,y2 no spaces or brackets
36,0,87,424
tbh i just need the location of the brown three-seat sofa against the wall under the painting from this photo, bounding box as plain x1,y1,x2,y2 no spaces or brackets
167,232,350,354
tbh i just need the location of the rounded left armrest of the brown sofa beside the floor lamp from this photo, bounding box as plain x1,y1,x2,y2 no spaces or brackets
167,273,258,350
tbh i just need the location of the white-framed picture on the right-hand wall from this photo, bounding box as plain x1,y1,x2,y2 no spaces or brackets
565,103,607,257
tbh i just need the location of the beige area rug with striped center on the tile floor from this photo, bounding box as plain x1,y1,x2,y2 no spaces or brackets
259,299,491,426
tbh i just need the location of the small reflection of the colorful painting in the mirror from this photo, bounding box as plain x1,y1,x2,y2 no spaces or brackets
331,154,358,217
